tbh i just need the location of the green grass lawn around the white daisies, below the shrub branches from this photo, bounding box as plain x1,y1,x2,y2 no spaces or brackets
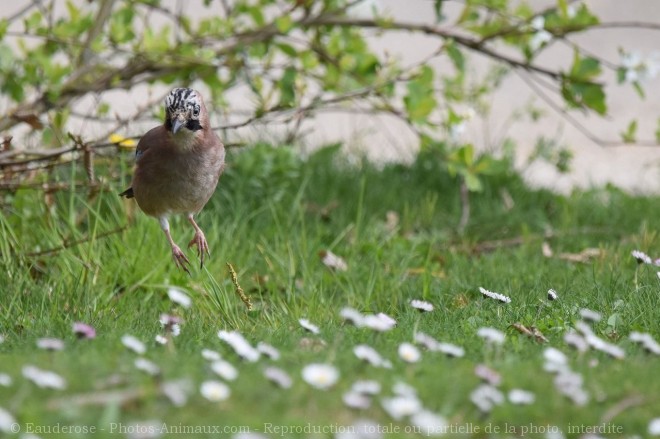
0,147,660,437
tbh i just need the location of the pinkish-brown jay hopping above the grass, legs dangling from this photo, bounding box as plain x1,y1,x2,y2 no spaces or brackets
119,88,225,274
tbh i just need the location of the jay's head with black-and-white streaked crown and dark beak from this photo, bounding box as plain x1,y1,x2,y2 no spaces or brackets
165,88,207,134
